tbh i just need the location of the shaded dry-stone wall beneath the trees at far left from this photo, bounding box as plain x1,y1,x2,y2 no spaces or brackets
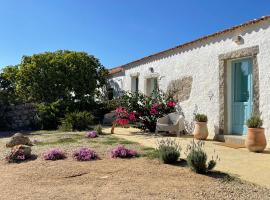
5,103,37,130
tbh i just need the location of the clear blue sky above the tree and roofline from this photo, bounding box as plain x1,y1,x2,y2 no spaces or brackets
0,0,270,68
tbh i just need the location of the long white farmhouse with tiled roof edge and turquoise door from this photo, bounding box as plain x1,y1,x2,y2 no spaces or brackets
109,16,270,142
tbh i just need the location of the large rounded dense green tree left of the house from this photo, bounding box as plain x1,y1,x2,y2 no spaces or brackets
17,50,107,104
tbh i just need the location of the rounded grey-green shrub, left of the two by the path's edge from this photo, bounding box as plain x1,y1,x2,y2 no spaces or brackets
157,138,181,164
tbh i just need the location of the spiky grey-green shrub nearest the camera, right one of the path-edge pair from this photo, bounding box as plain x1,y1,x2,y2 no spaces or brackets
187,140,219,174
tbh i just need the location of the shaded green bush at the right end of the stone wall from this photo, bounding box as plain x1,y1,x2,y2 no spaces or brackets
36,100,66,130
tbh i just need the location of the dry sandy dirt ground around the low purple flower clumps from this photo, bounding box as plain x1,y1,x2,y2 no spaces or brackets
0,130,270,200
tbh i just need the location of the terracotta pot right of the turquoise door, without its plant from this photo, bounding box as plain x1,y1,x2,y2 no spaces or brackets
245,128,267,152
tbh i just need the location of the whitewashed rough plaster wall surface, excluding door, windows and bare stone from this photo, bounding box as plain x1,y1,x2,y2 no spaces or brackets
108,21,270,138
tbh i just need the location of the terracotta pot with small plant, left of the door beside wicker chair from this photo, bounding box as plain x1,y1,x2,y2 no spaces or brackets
193,114,208,140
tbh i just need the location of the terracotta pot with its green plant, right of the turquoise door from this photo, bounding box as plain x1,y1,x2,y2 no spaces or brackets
245,116,267,152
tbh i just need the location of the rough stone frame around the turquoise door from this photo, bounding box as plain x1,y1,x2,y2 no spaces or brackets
219,46,260,134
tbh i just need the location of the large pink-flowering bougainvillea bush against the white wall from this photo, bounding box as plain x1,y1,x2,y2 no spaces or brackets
115,90,176,132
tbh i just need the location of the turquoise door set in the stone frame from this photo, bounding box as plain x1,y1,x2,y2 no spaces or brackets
231,59,252,135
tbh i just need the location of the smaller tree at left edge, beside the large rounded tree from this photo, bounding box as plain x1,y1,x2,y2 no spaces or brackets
0,65,19,105
